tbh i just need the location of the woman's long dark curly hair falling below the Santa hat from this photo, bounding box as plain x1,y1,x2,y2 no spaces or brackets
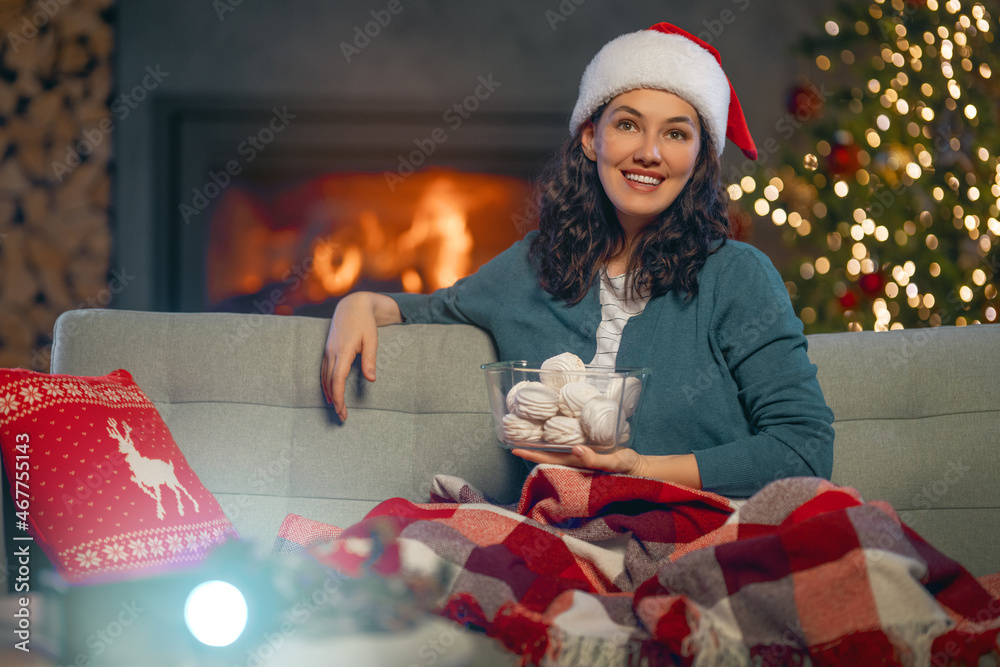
530,107,732,304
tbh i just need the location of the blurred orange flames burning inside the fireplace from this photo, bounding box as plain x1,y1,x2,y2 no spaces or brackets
207,170,530,312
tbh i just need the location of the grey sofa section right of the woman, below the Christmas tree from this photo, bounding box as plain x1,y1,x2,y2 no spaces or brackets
809,324,1000,575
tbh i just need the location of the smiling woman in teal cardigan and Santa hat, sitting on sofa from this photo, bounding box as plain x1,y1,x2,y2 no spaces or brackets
322,23,833,496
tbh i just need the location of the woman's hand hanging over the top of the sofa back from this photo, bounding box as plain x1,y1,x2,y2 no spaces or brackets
320,292,403,421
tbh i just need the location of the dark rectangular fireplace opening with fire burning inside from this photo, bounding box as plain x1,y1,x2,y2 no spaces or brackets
155,98,566,316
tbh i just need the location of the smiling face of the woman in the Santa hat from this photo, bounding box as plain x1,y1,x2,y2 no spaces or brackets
581,88,701,237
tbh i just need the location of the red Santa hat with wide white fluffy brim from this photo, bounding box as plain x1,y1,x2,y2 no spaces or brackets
569,23,757,160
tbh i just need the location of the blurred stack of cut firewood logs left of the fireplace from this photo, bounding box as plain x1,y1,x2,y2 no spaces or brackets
0,0,114,370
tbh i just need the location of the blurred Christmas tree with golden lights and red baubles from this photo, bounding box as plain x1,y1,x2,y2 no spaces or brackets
729,0,1000,333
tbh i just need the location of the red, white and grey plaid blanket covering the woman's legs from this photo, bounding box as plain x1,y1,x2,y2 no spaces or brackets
279,465,1000,665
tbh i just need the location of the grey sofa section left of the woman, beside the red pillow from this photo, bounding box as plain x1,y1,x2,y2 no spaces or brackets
42,310,526,551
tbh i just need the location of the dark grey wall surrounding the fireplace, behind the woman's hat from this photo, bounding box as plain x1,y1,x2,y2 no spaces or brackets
112,0,827,309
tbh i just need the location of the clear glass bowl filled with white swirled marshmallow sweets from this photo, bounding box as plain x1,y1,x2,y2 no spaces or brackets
482,361,650,453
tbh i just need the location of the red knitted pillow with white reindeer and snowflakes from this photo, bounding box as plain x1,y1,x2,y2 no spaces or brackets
0,368,236,582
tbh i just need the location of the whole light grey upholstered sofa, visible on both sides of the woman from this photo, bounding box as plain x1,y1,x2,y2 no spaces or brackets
5,310,1000,574
